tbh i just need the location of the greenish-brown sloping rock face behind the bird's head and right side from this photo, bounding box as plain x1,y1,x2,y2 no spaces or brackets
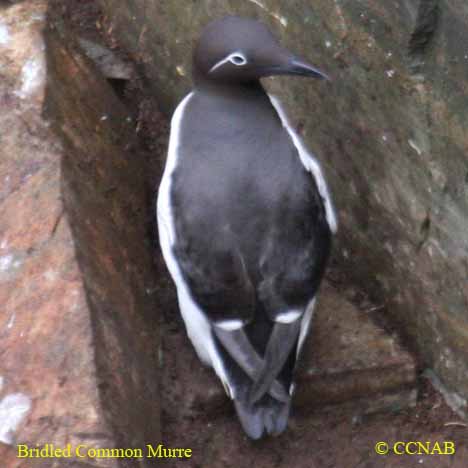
100,0,468,412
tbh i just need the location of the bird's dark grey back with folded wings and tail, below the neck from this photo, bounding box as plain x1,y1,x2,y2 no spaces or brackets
163,84,331,437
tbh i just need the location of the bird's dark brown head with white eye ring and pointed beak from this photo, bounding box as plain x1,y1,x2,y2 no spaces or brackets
193,16,329,83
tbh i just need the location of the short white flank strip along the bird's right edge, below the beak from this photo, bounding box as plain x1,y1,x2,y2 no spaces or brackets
268,94,338,233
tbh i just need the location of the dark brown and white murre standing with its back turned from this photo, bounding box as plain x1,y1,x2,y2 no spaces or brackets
156,16,337,440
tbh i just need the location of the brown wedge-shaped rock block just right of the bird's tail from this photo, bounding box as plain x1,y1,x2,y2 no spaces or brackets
296,283,417,413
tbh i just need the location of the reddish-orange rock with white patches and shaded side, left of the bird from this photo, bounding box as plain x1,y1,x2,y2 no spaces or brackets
0,0,159,467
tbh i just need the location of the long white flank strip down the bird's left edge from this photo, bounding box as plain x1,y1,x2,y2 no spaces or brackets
157,93,235,398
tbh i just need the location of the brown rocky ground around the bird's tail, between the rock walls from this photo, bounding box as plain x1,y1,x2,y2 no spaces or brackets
158,284,468,468
